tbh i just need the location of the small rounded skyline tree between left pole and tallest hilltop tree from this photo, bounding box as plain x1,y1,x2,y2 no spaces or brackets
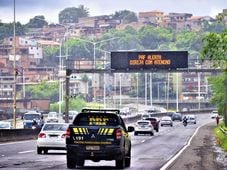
27,15,48,28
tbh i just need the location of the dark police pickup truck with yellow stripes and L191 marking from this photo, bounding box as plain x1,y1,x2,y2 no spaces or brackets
66,109,134,169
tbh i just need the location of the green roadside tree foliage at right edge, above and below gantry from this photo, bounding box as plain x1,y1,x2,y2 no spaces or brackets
201,29,227,126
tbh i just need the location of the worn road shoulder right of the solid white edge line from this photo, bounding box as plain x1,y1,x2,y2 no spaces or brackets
167,122,224,170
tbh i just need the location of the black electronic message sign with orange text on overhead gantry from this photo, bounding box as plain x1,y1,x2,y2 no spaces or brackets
111,51,188,71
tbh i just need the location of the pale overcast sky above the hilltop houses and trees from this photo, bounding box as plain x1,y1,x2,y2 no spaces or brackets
0,0,227,24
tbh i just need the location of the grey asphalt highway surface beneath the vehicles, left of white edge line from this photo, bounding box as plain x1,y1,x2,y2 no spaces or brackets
0,114,214,170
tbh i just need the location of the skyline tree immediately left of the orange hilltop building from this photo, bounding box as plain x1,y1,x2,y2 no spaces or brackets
113,10,138,24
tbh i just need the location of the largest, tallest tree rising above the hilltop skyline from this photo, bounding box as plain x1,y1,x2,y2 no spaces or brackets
58,5,89,24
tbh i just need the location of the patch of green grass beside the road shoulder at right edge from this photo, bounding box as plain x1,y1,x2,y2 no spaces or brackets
214,123,227,151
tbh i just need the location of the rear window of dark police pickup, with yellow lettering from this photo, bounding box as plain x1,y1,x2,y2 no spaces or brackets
74,113,119,126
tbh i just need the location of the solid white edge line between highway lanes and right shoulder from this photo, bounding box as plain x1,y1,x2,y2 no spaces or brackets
160,122,211,170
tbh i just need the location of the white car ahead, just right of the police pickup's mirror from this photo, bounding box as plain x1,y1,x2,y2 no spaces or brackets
134,120,154,136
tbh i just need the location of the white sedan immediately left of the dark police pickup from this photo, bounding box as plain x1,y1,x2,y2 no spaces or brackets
37,123,69,154
